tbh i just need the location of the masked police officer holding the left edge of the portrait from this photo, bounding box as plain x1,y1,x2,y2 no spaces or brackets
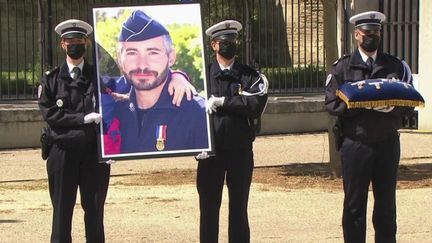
39,19,110,243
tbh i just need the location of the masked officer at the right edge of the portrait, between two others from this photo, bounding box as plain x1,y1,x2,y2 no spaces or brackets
196,20,268,243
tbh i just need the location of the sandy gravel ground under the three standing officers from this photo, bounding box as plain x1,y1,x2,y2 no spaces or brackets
0,131,432,243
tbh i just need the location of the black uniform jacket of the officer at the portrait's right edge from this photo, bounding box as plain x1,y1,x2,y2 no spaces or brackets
209,61,267,149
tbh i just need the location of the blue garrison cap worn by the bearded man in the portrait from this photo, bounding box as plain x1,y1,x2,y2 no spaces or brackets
119,10,169,41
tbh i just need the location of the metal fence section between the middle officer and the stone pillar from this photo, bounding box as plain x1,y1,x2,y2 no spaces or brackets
204,0,325,95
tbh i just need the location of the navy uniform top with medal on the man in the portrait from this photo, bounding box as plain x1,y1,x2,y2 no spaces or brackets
114,74,209,153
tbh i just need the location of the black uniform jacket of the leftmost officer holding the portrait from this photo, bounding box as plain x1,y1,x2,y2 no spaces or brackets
39,61,97,147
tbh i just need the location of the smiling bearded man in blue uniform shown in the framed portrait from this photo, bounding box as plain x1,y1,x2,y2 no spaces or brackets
114,10,209,153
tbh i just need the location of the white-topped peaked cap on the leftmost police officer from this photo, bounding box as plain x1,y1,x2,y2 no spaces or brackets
54,19,93,38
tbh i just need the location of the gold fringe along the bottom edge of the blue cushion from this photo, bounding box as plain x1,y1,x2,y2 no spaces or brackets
336,90,425,109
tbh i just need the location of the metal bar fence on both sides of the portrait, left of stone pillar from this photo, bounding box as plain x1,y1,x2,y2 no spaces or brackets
0,0,325,100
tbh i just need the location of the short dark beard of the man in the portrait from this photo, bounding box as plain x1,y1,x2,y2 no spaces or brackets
125,65,168,91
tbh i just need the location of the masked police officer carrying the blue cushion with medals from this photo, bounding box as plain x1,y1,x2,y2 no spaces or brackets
325,11,412,243
